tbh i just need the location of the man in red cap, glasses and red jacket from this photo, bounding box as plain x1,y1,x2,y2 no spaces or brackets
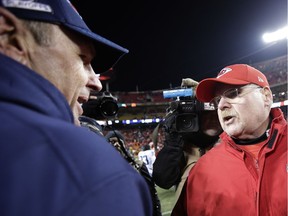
184,64,287,216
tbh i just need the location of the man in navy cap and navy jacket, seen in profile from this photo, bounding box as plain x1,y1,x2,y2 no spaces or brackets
0,0,152,216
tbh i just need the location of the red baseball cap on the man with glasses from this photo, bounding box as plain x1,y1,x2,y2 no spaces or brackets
196,64,269,102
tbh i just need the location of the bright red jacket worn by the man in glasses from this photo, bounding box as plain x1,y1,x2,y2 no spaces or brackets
184,108,287,216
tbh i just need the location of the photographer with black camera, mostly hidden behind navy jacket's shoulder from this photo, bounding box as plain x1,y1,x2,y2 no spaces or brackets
79,92,162,216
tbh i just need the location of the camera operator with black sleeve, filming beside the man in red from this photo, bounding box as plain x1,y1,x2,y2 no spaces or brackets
153,79,222,211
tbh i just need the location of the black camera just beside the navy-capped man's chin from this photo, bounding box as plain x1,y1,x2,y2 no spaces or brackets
82,91,119,120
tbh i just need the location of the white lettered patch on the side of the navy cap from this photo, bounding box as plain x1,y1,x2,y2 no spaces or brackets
2,0,52,13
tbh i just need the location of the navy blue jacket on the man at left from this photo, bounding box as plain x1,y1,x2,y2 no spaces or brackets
0,54,152,216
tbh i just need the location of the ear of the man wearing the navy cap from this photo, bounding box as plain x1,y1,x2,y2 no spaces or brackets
0,7,26,64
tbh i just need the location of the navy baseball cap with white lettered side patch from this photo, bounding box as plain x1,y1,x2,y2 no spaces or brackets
0,0,129,73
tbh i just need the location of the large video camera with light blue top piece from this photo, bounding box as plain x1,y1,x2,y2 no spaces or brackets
163,88,214,134
